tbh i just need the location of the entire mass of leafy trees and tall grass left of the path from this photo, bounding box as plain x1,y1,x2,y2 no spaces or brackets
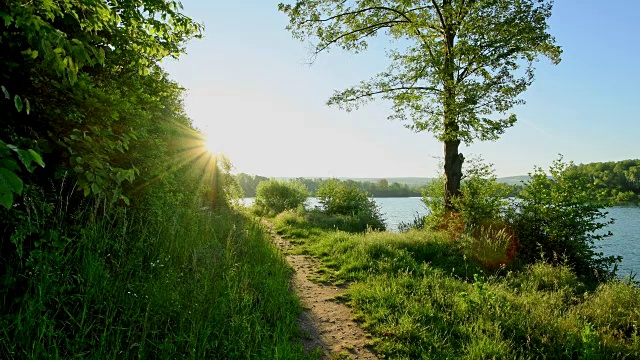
0,0,306,359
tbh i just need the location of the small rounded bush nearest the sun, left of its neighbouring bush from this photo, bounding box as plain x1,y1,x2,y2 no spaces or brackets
255,179,309,215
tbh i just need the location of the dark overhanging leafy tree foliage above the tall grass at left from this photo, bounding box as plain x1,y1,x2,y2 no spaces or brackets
0,0,202,208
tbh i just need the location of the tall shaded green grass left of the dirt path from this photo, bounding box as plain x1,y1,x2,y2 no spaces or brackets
0,204,308,359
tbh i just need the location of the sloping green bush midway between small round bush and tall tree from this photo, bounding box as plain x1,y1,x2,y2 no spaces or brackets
316,179,386,231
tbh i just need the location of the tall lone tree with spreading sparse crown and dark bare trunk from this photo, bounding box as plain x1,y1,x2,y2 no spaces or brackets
279,0,561,209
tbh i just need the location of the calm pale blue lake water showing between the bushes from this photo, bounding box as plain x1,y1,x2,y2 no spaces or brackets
243,197,640,276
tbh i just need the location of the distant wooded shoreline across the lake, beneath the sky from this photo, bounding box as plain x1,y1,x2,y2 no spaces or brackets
235,159,640,204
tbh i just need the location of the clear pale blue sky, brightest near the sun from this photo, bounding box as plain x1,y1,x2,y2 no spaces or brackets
164,0,640,178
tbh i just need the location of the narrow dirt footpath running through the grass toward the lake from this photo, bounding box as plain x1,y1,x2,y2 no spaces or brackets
265,223,378,359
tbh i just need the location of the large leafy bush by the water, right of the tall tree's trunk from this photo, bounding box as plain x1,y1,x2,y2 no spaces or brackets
508,158,619,279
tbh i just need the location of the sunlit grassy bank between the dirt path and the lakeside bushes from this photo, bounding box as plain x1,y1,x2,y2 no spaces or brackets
274,212,640,359
